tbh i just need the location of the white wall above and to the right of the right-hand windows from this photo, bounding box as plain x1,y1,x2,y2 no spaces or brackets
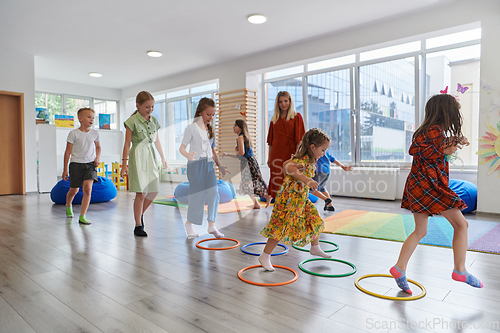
122,0,500,213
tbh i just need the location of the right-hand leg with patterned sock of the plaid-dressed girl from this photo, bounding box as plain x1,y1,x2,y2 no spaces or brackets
441,208,483,288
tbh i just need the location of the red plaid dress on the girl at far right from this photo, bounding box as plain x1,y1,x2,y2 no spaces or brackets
401,125,467,215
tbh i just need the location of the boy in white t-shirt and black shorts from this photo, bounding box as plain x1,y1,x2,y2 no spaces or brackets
62,108,101,225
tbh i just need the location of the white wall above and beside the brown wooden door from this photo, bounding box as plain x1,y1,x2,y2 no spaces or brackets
0,49,37,192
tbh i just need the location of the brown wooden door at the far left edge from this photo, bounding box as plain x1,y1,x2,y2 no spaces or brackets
0,91,26,195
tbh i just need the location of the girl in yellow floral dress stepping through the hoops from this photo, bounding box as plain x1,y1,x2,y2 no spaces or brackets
259,128,331,271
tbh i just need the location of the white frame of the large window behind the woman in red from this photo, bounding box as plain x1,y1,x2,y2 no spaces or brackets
260,23,481,169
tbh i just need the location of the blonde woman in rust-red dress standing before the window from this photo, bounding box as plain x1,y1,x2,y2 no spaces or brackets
267,91,305,198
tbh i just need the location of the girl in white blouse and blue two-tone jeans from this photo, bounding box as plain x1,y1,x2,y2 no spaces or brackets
179,97,229,238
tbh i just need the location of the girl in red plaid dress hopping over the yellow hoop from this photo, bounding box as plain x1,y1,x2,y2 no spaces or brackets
390,94,483,294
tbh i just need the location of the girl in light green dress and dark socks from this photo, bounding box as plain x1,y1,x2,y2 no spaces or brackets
120,91,167,236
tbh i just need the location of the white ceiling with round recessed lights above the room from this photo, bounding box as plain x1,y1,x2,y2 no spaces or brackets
0,0,452,88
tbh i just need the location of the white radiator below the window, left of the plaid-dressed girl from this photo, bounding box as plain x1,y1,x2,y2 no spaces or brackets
326,167,399,200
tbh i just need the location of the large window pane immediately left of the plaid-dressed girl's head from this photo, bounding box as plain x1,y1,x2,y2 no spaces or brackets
358,57,415,162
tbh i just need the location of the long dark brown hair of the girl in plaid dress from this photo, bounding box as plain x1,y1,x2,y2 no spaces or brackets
413,94,464,144
